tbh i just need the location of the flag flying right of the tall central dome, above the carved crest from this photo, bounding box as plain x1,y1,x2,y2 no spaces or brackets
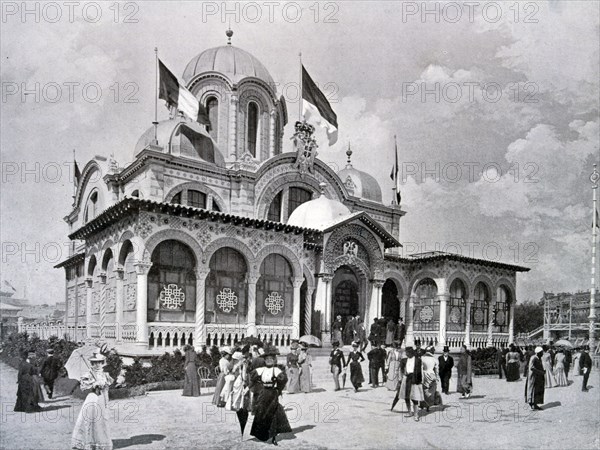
302,66,338,146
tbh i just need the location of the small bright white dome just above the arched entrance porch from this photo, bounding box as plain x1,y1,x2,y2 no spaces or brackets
287,194,351,230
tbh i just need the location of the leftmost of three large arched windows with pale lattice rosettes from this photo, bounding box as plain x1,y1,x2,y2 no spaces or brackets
148,240,196,322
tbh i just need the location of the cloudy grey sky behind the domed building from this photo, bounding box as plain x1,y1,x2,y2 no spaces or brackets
0,1,600,303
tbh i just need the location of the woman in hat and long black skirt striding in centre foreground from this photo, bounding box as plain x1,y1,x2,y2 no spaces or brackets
249,347,292,445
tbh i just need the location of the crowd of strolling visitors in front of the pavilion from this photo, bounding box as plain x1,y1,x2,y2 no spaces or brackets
9,330,592,449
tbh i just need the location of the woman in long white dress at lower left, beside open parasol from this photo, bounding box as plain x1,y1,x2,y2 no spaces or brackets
71,353,113,450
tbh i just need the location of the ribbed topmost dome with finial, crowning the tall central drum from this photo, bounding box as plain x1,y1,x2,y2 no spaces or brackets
183,30,275,90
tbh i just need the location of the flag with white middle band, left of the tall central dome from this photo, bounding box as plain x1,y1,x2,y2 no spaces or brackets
158,59,210,128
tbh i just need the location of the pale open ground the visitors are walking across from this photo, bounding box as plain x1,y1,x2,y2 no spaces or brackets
0,358,600,449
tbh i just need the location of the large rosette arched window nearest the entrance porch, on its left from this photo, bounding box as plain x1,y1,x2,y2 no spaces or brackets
256,253,294,325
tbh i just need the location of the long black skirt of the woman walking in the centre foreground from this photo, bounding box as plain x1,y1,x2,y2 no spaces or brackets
250,389,292,441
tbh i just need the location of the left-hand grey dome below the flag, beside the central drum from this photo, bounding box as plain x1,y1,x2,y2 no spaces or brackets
134,118,225,167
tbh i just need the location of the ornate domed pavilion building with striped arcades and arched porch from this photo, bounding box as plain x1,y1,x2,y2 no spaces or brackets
45,30,528,354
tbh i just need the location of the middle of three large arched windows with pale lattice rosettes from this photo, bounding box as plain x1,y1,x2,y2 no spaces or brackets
205,247,248,323
